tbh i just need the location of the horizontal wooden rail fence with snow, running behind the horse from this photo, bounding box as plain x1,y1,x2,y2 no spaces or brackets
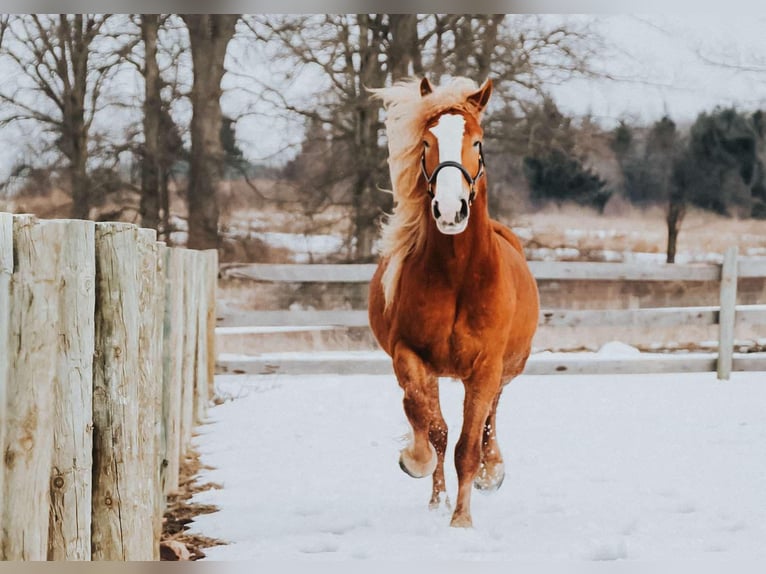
217,247,766,379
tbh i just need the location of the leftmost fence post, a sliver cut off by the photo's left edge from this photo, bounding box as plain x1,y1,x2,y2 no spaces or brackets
0,213,13,540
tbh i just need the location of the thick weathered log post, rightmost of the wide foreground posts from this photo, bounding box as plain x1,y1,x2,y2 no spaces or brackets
92,223,154,560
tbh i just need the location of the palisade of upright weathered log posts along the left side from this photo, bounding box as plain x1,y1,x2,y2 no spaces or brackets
0,213,218,560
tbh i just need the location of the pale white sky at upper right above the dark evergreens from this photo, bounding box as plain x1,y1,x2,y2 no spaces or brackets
552,14,766,129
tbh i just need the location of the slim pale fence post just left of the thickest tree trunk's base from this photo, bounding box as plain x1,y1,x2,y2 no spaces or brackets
161,247,186,495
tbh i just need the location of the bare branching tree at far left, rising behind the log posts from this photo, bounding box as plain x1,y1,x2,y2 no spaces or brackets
0,14,121,219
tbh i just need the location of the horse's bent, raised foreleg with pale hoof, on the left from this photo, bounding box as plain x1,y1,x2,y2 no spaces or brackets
393,344,438,478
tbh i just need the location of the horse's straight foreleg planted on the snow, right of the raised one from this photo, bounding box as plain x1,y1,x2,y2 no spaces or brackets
451,365,501,527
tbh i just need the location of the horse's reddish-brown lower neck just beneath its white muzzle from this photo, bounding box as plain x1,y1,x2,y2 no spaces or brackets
425,200,493,278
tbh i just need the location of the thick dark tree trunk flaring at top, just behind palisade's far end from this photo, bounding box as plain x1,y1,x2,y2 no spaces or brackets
181,14,239,249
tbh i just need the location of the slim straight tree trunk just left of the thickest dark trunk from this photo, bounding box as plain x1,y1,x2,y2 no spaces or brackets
141,14,162,229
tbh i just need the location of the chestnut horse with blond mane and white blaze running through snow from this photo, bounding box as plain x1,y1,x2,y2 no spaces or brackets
369,78,539,527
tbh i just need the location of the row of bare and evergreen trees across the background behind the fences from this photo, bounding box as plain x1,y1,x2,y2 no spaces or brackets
0,13,766,261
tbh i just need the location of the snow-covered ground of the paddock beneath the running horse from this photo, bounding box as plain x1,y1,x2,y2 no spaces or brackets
192,364,766,565
